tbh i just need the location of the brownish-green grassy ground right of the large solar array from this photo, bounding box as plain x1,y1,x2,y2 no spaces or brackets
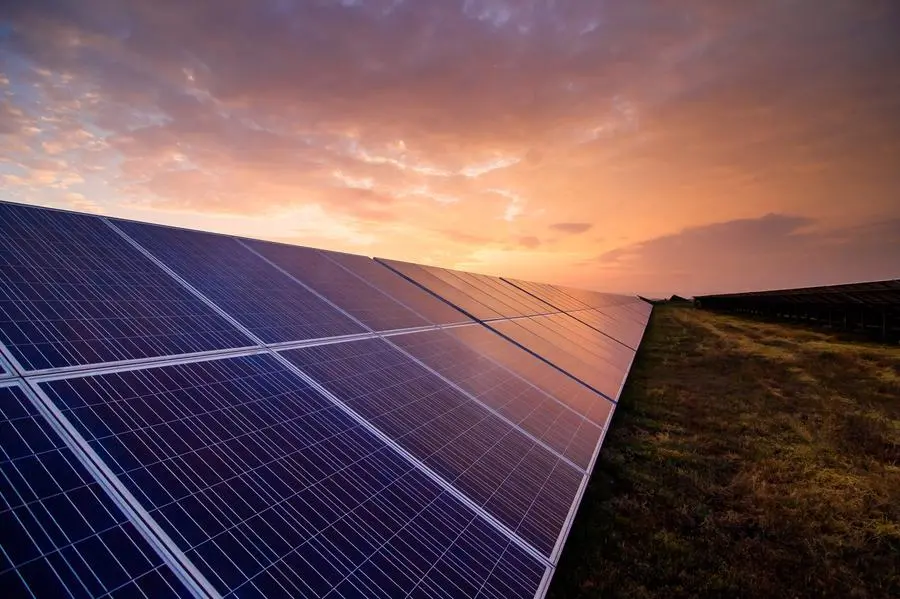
549,307,900,598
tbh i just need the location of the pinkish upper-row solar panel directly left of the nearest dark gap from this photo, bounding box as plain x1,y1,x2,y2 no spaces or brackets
322,251,471,324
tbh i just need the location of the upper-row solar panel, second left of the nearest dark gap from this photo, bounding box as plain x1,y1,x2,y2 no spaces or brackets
237,240,429,331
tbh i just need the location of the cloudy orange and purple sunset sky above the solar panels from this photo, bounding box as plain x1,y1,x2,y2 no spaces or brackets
0,0,900,296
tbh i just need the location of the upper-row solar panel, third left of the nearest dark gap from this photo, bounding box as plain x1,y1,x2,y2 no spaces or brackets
115,221,365,343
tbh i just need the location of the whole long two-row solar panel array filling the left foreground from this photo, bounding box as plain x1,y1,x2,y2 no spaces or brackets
0,203,650,599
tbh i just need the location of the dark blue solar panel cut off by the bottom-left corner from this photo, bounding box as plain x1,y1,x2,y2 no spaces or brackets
0,386,190,599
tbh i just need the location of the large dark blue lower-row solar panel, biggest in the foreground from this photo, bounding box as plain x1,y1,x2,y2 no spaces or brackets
42,354,545,599
